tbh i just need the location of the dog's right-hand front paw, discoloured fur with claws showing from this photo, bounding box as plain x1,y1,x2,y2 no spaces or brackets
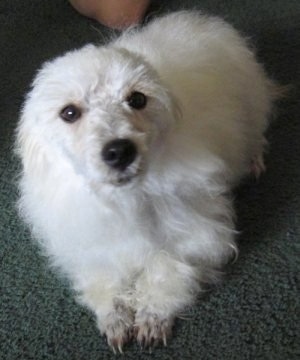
134,311,174,348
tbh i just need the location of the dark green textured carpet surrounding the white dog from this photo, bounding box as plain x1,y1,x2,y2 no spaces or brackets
0,0,300,360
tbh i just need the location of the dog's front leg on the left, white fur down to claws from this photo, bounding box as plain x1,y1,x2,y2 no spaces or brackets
80,276,134,353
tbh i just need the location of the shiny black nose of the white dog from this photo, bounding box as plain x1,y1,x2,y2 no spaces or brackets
101,139,137,171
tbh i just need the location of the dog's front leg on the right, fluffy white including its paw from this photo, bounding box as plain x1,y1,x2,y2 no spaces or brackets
134,251,198,347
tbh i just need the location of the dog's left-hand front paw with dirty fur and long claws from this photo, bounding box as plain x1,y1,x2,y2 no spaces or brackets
104,306,134,353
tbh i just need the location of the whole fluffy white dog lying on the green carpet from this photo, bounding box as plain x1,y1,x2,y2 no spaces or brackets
17,12,274,351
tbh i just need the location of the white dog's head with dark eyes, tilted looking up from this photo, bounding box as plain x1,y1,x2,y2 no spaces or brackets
18,45,177,188
